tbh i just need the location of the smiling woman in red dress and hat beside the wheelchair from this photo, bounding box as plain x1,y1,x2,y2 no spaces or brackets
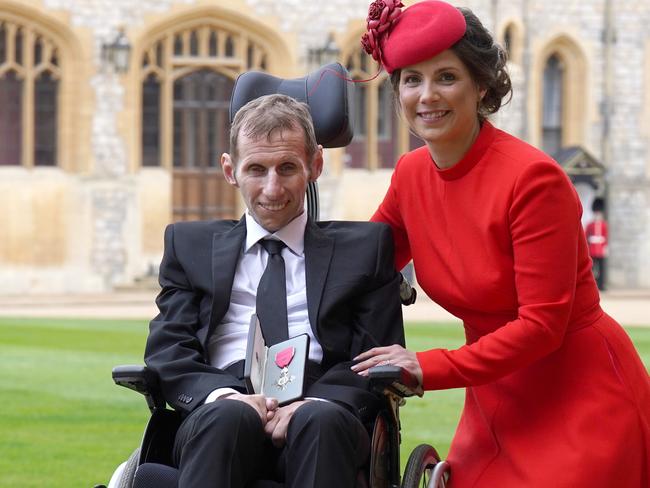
354,0,650,488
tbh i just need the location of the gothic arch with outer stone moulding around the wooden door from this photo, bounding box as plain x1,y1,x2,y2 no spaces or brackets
132,7,292,220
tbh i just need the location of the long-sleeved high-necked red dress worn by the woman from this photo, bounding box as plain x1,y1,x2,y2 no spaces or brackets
373,122,650,488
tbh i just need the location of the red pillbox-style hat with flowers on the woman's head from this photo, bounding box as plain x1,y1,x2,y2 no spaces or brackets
361,0,465,73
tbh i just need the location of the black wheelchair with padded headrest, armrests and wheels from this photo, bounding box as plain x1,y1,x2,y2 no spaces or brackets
95,63,450,488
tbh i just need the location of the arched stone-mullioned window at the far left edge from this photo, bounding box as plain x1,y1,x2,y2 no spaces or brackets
0,17,61,167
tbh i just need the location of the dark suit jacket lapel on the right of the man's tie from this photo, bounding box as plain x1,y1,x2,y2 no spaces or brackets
305,219,334,343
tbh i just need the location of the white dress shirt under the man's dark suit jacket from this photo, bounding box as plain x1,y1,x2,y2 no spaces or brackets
206,212,323,403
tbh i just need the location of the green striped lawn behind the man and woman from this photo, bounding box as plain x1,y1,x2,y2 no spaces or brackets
0,318,650,488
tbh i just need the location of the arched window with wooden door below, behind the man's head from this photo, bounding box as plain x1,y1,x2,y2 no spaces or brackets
140,19,268,220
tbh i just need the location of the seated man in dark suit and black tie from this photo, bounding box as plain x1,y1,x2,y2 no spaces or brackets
145,95,404,488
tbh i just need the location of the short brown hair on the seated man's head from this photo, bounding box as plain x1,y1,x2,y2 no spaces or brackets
230,94,318,164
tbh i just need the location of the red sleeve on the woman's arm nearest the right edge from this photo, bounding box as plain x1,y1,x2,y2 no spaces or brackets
417,161,582,390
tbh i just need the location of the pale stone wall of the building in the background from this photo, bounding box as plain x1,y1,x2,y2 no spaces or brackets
0,0,650,293
